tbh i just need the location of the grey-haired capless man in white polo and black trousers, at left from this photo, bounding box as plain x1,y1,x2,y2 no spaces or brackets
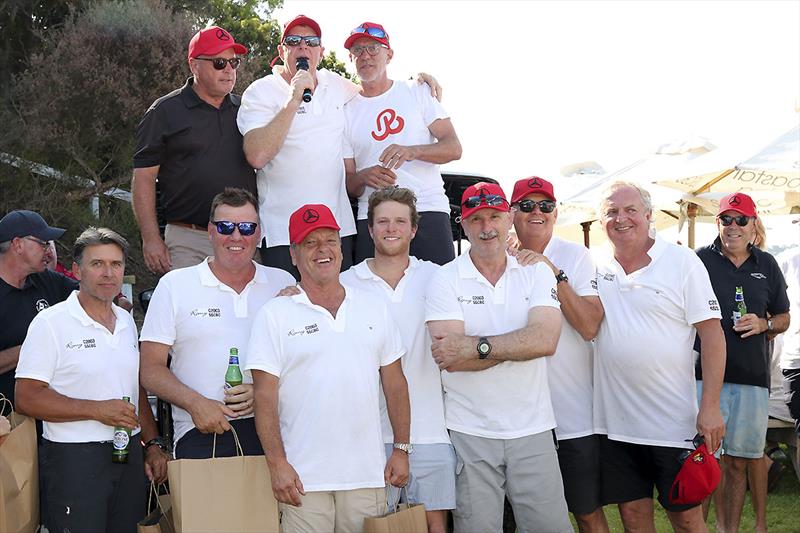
16,228,150,533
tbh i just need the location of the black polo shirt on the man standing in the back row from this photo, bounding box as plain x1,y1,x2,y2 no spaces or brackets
133,78,256,227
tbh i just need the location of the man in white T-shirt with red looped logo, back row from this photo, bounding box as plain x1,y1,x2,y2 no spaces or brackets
344,22,461,265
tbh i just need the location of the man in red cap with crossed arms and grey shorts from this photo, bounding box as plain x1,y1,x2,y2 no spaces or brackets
425,183,572,532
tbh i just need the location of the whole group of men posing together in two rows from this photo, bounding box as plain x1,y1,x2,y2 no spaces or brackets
0,9,798,532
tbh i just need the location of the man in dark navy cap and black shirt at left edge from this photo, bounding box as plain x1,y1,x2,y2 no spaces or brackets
0,210,78,401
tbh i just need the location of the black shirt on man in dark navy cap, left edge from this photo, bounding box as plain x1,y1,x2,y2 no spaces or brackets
0,270,78,401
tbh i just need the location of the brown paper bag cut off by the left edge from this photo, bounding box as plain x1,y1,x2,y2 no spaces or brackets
0,395,39,533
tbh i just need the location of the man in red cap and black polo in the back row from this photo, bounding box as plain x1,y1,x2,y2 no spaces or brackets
131,26,256,273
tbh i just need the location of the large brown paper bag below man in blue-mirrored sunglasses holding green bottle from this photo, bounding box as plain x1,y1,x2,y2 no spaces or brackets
167,430,280,533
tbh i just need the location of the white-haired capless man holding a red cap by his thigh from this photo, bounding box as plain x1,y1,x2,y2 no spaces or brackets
594,182,725,531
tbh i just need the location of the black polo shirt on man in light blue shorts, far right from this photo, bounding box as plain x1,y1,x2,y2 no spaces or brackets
695,237,789,388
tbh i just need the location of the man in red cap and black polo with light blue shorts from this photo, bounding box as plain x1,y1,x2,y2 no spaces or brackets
695,192,789,531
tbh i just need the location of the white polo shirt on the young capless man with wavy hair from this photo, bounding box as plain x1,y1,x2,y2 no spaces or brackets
340,257,450,444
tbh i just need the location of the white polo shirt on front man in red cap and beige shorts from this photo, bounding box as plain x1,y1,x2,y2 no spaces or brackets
246,287,405,492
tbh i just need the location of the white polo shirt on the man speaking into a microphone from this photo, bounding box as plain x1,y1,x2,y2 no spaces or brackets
236,69,358,246
